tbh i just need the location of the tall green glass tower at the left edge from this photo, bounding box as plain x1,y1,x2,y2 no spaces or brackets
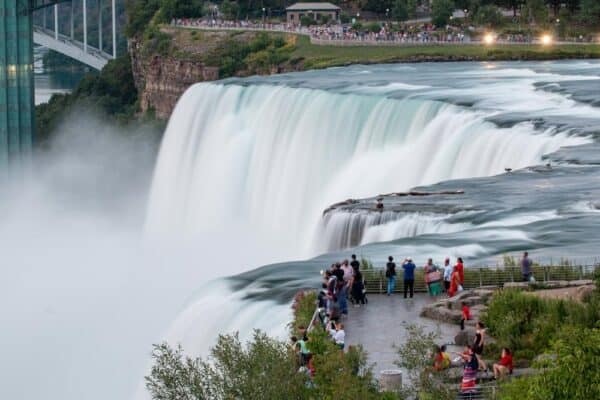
0,0,35,169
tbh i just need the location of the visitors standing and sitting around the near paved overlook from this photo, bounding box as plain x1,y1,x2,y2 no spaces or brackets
292,252,533,396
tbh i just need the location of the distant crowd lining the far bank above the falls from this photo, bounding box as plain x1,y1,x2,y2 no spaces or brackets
171,18,469,44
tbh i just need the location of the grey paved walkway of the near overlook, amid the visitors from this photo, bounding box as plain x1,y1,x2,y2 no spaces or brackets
344,293,459,376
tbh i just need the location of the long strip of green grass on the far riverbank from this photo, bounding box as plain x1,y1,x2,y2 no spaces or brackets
292,36,600,69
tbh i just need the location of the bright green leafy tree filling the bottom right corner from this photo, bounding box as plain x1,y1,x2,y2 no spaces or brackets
500,327,600,400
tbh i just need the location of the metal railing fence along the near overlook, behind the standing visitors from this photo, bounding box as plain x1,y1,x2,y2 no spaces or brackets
361,264,600,293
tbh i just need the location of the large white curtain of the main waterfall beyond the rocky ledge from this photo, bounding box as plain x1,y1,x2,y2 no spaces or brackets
146,83,586,262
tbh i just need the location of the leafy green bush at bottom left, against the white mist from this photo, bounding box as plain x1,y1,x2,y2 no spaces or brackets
146,331,307,400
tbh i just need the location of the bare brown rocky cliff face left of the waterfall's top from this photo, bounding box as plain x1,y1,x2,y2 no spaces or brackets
129,40,219,119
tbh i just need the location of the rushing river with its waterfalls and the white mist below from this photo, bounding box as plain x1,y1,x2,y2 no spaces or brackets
0,61,600,399
